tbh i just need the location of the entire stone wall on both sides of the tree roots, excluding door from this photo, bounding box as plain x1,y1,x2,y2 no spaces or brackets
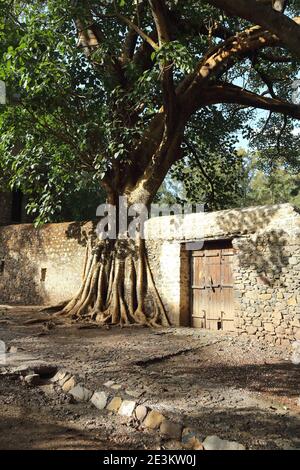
0,204,300,344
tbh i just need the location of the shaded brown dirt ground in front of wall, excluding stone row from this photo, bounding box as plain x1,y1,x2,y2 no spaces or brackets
0,306,300,450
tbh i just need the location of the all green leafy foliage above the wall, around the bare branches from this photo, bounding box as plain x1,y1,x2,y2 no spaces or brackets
0,0,299,223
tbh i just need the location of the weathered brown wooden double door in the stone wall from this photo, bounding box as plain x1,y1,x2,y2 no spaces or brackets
191,240,234,331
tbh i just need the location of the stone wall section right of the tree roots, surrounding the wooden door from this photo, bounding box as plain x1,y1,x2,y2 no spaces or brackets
146,204,300,344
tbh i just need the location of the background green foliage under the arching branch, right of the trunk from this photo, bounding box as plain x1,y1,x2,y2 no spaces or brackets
166,107,251,210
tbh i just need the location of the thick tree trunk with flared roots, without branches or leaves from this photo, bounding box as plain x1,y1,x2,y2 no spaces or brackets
55,118,184,326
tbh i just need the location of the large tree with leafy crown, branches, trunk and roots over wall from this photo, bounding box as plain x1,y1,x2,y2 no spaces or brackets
0,0,300,325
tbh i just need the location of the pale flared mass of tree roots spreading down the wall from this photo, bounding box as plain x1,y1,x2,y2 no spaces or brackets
55,235,169,327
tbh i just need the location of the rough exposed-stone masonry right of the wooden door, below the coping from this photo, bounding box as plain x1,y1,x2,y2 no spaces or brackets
234,234,300,344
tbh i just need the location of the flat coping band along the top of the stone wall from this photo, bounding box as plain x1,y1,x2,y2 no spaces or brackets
0,203,300,241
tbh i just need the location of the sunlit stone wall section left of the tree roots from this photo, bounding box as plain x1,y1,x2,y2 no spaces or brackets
0,223,92,305
